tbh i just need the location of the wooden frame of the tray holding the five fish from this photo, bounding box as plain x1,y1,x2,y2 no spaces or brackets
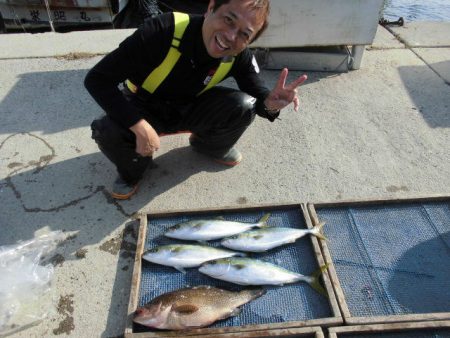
125,204,343,337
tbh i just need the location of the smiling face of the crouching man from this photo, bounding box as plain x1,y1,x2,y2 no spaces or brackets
202,0,264,58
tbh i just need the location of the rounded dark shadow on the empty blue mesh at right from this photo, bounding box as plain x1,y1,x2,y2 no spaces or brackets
388,232,450,314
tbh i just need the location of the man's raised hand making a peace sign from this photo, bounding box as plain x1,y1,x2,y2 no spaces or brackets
264,68,308,111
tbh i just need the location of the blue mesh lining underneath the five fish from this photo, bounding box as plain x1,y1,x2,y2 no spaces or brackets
135,208,332,332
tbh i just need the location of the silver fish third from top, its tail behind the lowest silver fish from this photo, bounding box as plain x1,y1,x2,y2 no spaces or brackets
142,244,245,273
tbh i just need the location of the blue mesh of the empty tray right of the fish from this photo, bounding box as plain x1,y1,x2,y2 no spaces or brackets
316,202,450,317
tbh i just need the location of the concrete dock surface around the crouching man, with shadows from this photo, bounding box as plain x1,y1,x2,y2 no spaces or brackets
0,22,450,337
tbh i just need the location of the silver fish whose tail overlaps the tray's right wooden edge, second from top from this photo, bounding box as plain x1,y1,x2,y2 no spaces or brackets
221,223,325,252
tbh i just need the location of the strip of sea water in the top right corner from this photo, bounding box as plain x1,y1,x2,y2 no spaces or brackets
380,0,450,22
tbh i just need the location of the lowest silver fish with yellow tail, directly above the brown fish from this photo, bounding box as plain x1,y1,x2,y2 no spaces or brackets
198,257,327,294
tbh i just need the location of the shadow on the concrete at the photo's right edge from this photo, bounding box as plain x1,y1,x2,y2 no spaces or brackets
399,62,450,128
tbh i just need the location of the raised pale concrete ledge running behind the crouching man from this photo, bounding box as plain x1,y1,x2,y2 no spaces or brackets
0,22,450,59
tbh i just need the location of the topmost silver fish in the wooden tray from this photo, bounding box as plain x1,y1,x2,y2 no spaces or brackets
164,214,270,241
